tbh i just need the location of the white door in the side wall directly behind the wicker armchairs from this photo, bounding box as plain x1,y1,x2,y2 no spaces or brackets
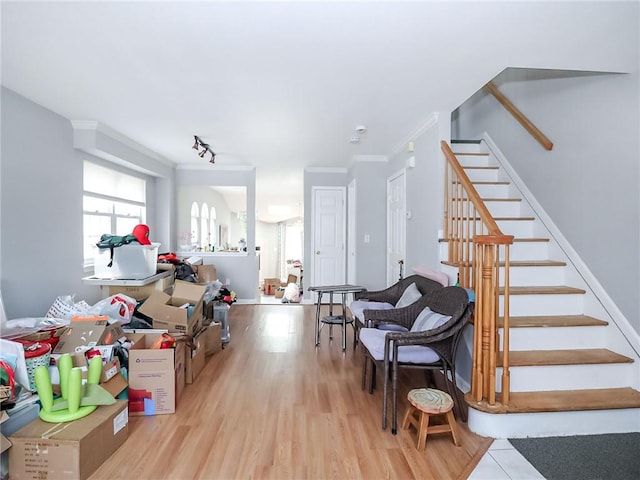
387,169,407,285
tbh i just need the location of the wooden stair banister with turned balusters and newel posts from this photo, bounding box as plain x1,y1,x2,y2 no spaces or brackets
440,141,513,405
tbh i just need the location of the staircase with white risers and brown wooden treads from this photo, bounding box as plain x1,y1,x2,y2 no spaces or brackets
443,137,640,438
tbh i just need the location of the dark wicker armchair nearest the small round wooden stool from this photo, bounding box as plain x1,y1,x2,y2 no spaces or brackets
360,287,474,435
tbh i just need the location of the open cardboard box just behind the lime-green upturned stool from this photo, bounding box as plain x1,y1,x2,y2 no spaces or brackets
53,315,125,354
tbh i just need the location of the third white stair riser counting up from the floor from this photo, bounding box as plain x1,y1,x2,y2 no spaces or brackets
500,327,607,351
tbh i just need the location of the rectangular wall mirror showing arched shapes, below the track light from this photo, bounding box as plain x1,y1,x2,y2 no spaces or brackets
177,185,247,252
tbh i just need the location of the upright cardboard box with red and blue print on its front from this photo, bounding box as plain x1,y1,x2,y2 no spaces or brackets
128,333,179,415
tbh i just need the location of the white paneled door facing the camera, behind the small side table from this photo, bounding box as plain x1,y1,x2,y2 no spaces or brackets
311,187,346,286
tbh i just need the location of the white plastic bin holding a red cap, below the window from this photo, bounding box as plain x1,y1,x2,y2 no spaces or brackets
93,243,160,280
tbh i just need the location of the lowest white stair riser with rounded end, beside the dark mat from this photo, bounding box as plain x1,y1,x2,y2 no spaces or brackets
467,408,640,438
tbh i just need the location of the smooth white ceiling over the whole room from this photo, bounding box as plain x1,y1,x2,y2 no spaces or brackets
1,1,625,220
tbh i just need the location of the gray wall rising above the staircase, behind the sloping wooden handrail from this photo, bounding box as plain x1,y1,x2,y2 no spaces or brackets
453,70,640,331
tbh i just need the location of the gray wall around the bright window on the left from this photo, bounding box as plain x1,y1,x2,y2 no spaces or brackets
0,87,174,318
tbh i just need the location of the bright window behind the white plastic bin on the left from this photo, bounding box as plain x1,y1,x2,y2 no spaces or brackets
82,161,147,266
